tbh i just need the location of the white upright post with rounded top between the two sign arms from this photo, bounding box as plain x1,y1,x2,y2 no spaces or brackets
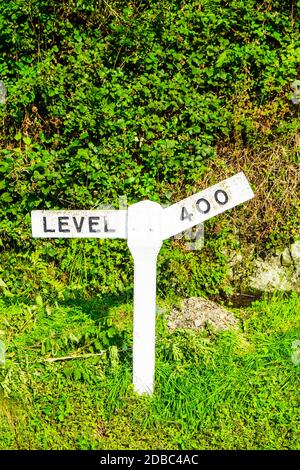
127,201,162,394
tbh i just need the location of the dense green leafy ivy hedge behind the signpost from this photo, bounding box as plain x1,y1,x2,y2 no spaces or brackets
0,0,300,298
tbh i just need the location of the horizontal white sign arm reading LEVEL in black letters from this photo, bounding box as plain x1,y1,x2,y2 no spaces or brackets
31,210,127,238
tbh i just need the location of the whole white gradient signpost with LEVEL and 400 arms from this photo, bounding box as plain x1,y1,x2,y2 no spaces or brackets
31,173,254,394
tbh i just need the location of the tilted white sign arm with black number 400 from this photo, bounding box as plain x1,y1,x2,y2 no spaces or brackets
162,172,254,240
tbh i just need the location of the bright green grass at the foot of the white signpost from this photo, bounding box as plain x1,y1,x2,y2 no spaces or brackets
0,294,300,449
